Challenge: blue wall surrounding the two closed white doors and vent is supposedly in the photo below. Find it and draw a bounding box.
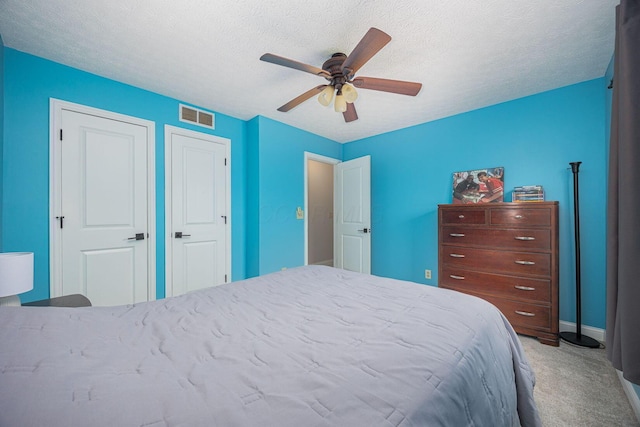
[0,48,246,301]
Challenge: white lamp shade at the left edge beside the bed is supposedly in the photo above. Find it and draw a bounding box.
[0,252,33,297]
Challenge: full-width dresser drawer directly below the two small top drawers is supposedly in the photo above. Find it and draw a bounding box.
[440,226,551,251]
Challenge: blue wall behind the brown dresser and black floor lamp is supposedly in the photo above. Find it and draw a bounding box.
[344,78,608,328]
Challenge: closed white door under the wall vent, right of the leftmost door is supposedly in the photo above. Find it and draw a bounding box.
[166,127,231,296]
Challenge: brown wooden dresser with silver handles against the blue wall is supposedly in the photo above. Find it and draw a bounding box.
[438,202,559,346]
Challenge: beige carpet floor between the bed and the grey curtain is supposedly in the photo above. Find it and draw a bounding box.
[520,335,640,427]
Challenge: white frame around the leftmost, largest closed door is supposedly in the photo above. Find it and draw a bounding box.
[49,98,156,301]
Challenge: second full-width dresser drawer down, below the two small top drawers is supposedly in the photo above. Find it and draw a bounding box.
[441,245,551,277]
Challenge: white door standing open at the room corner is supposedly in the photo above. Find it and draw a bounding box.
[333,156,371,273]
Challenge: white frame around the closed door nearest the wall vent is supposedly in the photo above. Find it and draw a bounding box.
[164,125,233,296]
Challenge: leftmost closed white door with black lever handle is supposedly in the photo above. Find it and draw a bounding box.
[52,102,155,306]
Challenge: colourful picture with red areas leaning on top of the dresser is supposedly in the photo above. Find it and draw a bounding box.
[452,167,504,204]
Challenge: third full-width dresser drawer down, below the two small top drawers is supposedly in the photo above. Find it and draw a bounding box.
[439,266,551,304]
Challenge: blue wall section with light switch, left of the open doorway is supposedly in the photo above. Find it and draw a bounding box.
[247,117,343,276]
